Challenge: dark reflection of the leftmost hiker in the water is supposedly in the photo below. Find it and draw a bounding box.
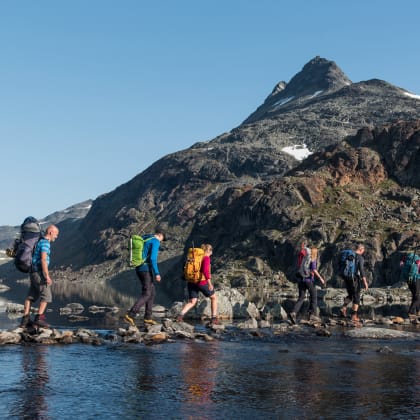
[12,346,50,420]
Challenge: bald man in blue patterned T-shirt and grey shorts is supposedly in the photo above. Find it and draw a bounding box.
[20,225,59,328]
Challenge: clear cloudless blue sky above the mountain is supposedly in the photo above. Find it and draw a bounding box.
[0,0,420,225]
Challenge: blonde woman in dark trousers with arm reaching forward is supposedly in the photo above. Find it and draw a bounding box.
[289,247,325,324]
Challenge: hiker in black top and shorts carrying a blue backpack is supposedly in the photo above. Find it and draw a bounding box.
[340,244,368,322]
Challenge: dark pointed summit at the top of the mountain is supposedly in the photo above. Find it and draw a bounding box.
[244,56,352,124]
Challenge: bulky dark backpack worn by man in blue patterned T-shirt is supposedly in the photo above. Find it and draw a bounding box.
[6,216,42,273]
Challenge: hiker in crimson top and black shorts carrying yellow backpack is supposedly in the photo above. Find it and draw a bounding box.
[176,244,218,325]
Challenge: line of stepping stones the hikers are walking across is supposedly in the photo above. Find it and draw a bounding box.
[0,316,420,346]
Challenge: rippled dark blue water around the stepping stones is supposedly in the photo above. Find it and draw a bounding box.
[0,272,420,420]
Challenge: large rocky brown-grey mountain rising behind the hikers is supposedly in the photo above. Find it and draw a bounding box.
[0,57,420,305]
